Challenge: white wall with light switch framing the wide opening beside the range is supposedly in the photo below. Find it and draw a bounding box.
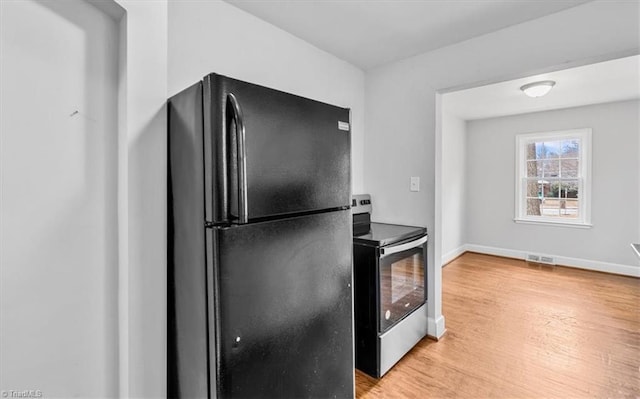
[364,1,640,335]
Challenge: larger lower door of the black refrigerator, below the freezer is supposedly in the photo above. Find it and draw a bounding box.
[207,210,354,398]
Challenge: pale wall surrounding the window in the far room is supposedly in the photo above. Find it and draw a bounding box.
[466,101,640,267]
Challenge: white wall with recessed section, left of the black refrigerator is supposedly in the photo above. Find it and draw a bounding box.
[0,0,167,397]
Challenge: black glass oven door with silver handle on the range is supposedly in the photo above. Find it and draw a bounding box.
[378,235,428,334]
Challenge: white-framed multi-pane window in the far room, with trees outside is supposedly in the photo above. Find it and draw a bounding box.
[515,129,591,227]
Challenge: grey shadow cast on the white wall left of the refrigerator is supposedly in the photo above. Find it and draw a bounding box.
[128,106,167,396]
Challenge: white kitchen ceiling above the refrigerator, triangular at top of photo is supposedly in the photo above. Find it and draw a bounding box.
[225,0,589,70]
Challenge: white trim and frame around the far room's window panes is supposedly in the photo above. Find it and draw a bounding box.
[514,128,593,228]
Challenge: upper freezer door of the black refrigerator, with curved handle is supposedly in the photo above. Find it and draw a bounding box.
[203,74,351,223]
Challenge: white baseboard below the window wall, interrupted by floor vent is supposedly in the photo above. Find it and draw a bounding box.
[464,244,640,277]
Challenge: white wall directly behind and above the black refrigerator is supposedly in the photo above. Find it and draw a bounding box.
[168,0,364,193]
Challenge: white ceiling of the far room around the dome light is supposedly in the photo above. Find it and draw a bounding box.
[443,55,640,120]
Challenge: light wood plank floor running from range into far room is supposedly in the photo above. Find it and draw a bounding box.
[356,253,640,398]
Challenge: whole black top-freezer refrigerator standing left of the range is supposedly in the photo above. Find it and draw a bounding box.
[167,74,354,398]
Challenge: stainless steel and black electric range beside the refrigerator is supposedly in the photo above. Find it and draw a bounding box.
[351,194,428,378]
